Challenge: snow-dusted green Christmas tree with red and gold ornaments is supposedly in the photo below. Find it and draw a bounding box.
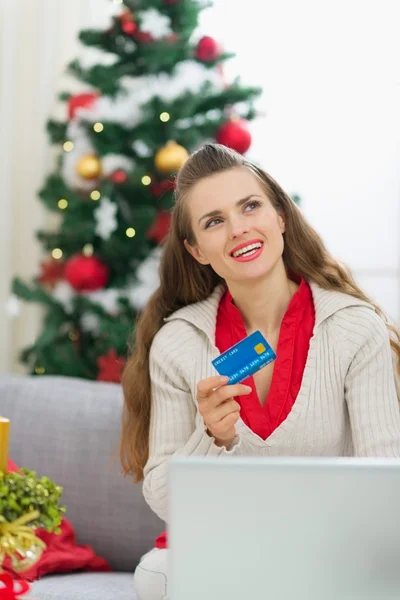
[13,0,261,381]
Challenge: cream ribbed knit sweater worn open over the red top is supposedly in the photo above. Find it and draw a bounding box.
[143,283,400,520]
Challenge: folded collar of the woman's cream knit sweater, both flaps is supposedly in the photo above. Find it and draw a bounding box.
[164,281,373,344]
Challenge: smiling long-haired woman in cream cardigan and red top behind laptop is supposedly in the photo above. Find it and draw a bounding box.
[121,144,400,600]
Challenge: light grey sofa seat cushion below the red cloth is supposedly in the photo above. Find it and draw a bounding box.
[29,573,137,600]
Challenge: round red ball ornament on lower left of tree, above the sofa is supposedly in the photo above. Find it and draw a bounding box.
[64,254,109,292]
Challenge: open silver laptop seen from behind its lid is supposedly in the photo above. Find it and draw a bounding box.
[168,457,400,600]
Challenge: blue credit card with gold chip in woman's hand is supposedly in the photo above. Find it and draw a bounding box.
[212,331,276,384]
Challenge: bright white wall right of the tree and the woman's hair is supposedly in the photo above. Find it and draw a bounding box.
[202,0,400,322]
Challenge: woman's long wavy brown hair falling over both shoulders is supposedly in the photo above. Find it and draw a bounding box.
[120,144,400,481]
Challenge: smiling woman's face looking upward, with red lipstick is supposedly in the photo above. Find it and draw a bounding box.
[185,168,285,285]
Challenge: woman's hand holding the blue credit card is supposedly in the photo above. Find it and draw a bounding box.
[197,376,251,447]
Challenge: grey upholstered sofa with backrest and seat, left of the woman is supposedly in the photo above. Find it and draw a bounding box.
[0,375,165,600]
